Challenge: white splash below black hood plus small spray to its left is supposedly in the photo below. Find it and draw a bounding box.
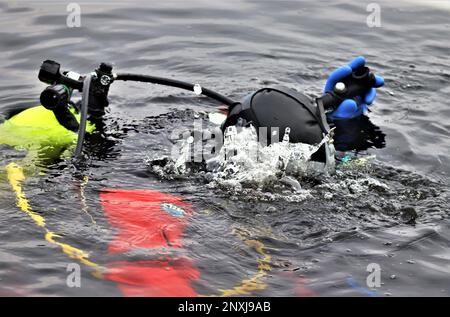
[146,126,331,193]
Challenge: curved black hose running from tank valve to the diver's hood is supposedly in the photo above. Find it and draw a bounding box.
[115,74,237,107]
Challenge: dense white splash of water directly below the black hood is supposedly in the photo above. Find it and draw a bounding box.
[209,126,328,189]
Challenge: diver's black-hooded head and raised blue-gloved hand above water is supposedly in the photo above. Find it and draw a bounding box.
[222,56,384,166]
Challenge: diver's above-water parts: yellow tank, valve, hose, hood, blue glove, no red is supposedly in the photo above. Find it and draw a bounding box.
[0,56,384,165]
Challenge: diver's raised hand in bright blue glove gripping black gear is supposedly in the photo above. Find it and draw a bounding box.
[324,56,384,121]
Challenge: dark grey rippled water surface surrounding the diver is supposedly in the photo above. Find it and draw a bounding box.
[0,0,450,296]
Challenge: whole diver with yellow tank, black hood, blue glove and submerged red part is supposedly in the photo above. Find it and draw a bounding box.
[0,57,384,296]
